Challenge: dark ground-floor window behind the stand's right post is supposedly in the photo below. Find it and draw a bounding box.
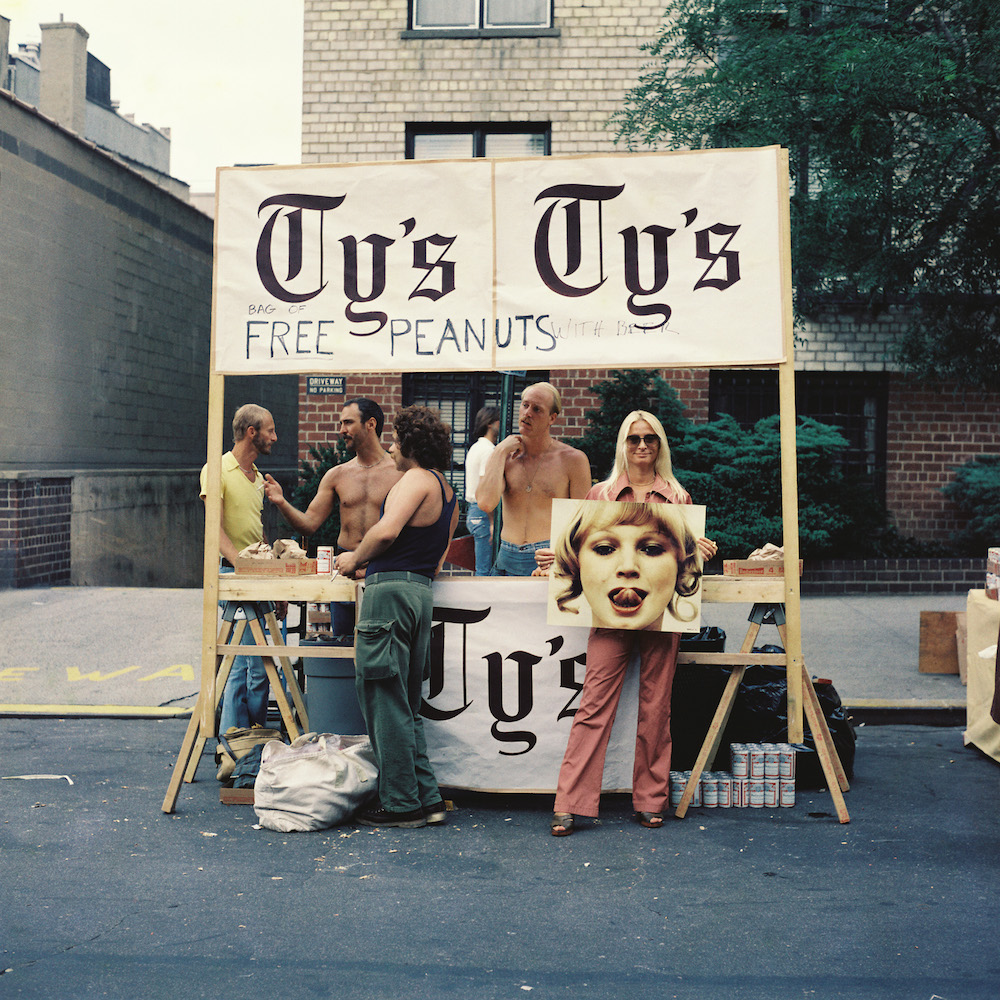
[709,369,888,502]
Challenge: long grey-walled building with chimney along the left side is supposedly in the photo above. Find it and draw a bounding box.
[0,17,297,587]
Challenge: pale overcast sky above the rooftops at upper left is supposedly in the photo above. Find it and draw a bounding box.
[0,0,303,191]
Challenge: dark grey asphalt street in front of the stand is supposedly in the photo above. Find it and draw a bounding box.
[0,716,1000,1000]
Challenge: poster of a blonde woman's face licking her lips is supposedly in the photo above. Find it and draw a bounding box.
[546,500,705,632]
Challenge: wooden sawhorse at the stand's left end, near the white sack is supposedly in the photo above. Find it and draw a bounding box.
[163,601,309,812]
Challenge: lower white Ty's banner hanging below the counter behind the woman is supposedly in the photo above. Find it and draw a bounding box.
[422,577,638,792]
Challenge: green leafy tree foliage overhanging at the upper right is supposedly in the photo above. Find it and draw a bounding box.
[614,0,1000,388]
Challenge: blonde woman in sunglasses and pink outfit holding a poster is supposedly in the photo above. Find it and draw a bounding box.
[551,410,717,837]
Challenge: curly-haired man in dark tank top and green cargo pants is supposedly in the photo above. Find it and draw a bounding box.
[336,406,458,827]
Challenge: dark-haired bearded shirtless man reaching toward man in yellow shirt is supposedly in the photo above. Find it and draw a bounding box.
[264,397,403,572]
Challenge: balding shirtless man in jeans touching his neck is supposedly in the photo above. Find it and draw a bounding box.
[476,382,591,576]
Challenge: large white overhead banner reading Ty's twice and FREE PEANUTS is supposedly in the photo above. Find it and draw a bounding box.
[213,147,787,374]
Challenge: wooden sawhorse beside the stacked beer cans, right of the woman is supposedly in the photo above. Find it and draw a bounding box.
[674,604,851,823]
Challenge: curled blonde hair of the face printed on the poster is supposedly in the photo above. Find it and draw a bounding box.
[553,500,702,621]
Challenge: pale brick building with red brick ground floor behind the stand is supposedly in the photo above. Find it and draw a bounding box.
[299,0,1000,556]
